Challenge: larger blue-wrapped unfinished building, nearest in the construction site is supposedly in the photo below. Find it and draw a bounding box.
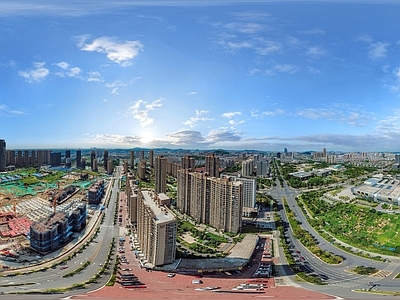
[30,201,87,254]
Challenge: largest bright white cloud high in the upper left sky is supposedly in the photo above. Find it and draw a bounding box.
[77,35,143,67]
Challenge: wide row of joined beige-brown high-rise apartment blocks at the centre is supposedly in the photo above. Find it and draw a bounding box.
[177,169,243,233]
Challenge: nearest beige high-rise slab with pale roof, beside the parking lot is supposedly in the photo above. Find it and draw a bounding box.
[137,190,177,266]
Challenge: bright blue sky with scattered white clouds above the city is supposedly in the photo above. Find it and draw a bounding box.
[0,0,400,152]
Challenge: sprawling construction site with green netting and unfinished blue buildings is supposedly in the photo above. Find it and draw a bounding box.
[0,170,104,270]
